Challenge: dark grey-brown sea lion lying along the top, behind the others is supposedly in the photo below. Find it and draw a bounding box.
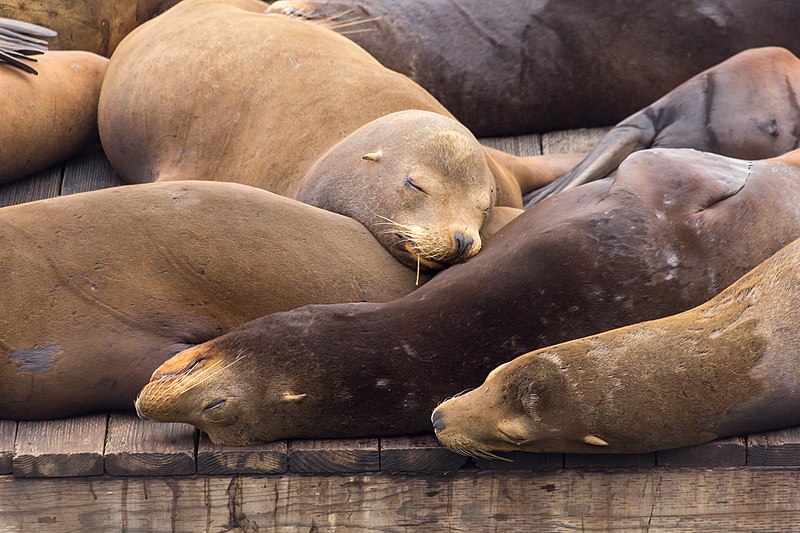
[270,0,800,137]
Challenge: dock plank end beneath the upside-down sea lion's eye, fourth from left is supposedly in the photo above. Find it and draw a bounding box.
[197,433,289,475]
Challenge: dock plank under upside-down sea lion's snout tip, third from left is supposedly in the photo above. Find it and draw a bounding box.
[105,414,195,476]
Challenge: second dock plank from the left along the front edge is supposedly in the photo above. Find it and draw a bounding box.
[13,415,107,477]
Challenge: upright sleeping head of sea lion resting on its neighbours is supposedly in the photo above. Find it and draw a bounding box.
[297,111,495,270]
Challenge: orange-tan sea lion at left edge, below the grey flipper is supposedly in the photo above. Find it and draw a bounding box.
[0,51,108,183]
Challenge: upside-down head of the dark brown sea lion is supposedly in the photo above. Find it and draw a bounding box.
[136,328,326,446]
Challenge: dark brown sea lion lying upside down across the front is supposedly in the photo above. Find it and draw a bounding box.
[137,149,800,444]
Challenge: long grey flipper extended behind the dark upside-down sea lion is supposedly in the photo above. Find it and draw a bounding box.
[523,111,656,209]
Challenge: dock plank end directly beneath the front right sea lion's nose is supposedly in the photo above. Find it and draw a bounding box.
[380,435,467,472]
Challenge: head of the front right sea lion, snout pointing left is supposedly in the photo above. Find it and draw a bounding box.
[431,349,608,458]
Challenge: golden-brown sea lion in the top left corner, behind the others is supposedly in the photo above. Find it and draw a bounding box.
[2,0,180,57]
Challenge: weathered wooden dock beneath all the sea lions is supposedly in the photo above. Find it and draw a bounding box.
[0,130,800,533]
